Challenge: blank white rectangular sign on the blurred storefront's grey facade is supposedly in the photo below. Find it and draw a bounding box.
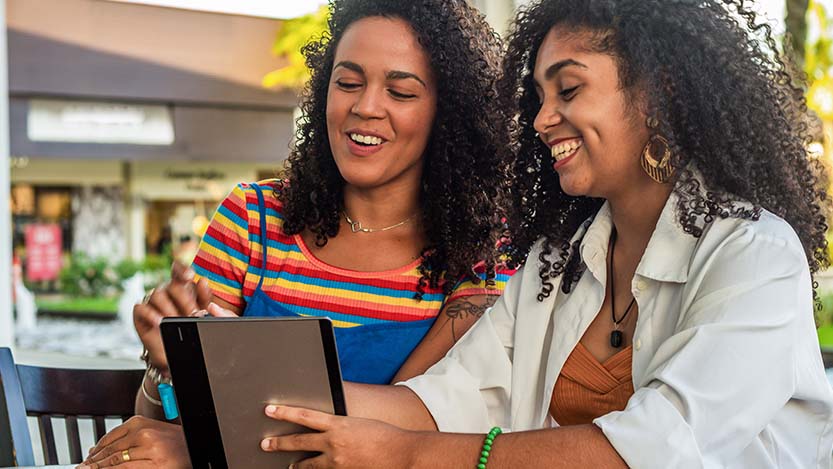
[27,99,174,145]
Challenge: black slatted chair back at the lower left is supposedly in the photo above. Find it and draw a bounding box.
[0,347,144,466]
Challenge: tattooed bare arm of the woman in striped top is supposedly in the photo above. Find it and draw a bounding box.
[392,295,498,383]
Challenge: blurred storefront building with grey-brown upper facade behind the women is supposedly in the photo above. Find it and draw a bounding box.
[7,0,297,286]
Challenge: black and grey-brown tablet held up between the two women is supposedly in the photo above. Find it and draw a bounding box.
[161,318,347,469]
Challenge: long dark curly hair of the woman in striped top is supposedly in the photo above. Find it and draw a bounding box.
[276,0,511,298]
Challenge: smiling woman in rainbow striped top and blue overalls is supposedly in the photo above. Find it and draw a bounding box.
[81,0,512,467]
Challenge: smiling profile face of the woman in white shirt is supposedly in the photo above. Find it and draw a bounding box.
[533,26,650,199]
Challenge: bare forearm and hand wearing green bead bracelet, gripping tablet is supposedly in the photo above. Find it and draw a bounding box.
[261,402,627,469]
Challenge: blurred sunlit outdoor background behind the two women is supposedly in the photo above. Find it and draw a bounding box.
[0,0,833,370]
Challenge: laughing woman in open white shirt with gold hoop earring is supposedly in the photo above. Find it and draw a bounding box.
[133,0,833,469]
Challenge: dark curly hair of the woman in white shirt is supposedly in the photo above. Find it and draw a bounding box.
[499,0,829,301]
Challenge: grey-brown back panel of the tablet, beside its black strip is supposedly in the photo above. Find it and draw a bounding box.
[166,319,340,469]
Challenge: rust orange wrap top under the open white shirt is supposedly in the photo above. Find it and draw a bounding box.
[550,342,633,425]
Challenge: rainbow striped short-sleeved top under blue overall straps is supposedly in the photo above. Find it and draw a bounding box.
[193,179,514,329]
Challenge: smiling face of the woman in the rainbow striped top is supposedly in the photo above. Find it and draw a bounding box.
[327,17,437,189]
